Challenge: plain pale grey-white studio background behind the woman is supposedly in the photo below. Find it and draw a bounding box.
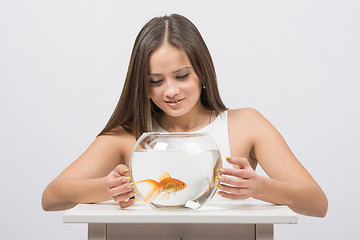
[0,0,360,240]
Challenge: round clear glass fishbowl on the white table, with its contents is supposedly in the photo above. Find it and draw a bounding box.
[130,132,222,209]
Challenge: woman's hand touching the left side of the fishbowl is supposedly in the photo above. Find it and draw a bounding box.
[105,164,136,208]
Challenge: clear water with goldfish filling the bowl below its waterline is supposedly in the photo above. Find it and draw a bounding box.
[131,150,221,209]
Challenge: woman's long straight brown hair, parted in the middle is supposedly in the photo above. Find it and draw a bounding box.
[98,14,227,138]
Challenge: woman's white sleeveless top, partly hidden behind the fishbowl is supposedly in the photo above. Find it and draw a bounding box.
[153,110,233,168]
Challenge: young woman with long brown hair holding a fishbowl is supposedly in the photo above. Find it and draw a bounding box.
[42,14,328,217]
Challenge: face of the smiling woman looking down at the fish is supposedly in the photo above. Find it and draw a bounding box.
[148,44,202,117]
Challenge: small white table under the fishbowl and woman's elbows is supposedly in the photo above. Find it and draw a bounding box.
[64,200,298,240]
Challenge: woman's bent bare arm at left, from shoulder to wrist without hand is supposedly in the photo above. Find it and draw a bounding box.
[42,129,134,211]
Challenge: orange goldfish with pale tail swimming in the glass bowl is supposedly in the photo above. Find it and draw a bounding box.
[135,172,186,202]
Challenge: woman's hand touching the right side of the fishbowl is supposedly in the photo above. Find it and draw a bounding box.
[218,157,258,199]
